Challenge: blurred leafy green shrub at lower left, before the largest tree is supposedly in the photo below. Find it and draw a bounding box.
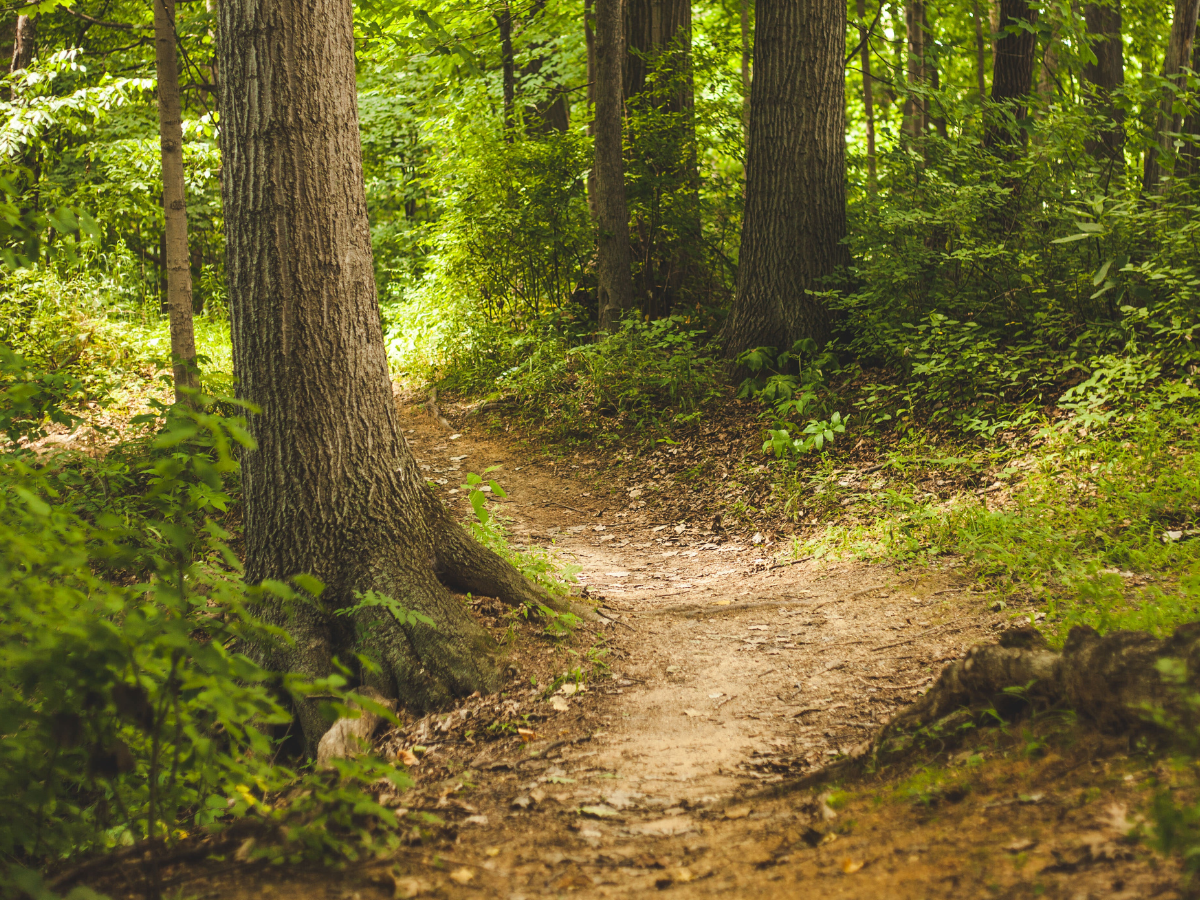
[0,382,406,883]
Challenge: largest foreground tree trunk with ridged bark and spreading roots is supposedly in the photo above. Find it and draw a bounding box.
[220,0,571,752]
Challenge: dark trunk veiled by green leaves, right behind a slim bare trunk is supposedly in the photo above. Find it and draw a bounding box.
[623,0,700,318]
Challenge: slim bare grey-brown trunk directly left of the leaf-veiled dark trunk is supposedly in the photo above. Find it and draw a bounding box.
[593,0,634,331]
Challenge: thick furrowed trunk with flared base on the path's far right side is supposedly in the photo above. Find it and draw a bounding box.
[724,0,846,358]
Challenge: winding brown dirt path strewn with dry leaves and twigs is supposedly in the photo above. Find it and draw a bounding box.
[117,403,1186,900]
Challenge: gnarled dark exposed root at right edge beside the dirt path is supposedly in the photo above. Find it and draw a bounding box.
[875,623,1200,751]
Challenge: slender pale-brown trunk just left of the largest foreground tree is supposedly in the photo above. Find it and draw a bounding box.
[154,0,199,402]
